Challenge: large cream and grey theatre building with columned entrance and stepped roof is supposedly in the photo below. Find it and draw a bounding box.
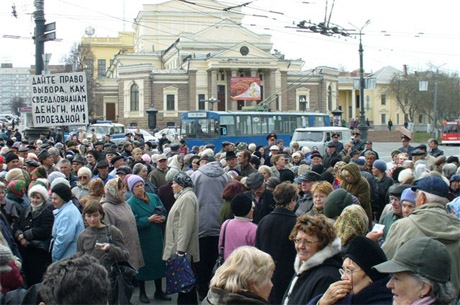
[92,0,339,128]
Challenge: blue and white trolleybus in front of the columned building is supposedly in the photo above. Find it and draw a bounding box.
[180,111,330,149]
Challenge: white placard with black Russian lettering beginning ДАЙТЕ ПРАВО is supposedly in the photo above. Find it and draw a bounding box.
[31,72,88,127]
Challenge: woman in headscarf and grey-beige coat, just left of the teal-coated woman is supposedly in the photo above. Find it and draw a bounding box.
[101,178,144,269]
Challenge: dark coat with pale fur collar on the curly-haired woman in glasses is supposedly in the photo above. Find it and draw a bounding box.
[282,238,342,305]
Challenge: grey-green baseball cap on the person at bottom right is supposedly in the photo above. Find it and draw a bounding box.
[373,236,451,283]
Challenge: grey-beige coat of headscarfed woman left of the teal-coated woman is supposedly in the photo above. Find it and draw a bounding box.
[102,200,144,269]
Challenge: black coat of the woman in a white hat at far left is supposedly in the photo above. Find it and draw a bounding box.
[13,203,54,286]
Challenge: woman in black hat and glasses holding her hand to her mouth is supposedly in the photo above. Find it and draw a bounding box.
[308,236,393,305]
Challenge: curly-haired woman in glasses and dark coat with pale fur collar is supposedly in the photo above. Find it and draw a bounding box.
[282,215,342,305]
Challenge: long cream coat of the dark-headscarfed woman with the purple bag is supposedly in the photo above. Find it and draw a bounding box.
[163,187,200,263]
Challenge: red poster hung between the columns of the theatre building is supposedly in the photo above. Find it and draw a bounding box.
[230,77,261,101]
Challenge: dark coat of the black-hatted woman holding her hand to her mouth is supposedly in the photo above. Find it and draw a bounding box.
[307,276,393,305]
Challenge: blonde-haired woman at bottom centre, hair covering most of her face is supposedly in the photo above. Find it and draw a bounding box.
[202,246,275,305]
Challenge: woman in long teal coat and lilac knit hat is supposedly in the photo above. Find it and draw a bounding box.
[128,175,171,303]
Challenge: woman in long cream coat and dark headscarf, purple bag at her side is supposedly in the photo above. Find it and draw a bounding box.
[163,172,200,304]
